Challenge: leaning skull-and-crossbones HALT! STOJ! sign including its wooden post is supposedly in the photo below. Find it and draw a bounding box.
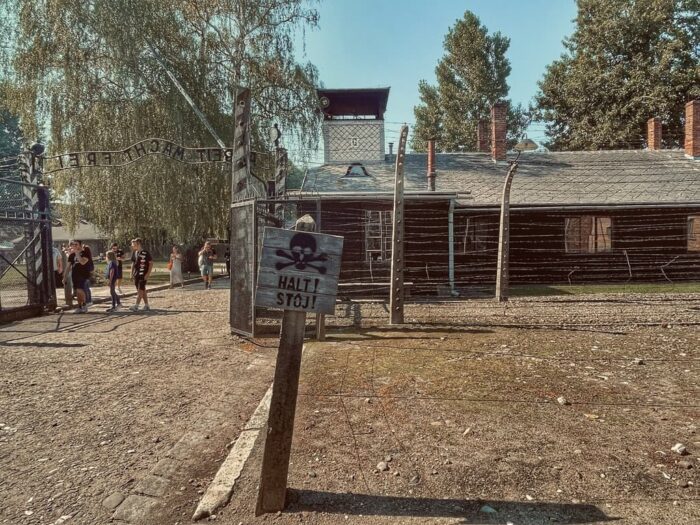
[255,215,343,516]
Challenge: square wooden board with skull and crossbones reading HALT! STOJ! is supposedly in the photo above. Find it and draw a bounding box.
[255,228,343,314]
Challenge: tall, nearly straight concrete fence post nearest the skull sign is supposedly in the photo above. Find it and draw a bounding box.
[389,124,408,324]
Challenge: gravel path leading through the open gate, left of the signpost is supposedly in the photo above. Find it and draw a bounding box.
[0,281,276,525]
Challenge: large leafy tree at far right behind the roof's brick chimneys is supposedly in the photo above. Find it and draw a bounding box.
[535,0,700,150]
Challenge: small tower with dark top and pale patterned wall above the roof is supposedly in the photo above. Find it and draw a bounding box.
[318,88,389,163]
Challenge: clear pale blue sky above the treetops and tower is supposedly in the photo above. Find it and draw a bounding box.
[298,0,576,151]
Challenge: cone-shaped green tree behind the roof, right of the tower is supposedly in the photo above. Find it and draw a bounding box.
[411,11,527,152]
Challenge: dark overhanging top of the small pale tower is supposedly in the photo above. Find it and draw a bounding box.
[317,87,389,120]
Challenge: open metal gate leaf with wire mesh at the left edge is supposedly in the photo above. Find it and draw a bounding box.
[0,152,56,322]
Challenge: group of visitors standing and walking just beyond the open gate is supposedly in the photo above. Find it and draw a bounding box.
[58,238,224,313]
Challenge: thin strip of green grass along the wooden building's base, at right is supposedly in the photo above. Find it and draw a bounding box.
[509,282,700,297]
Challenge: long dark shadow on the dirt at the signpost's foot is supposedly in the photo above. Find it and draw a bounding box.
[287,489,620,525]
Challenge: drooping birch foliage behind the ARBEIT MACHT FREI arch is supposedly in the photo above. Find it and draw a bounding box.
[0,0,319,243]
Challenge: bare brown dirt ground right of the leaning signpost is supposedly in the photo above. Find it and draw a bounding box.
[217,296,700,525]
